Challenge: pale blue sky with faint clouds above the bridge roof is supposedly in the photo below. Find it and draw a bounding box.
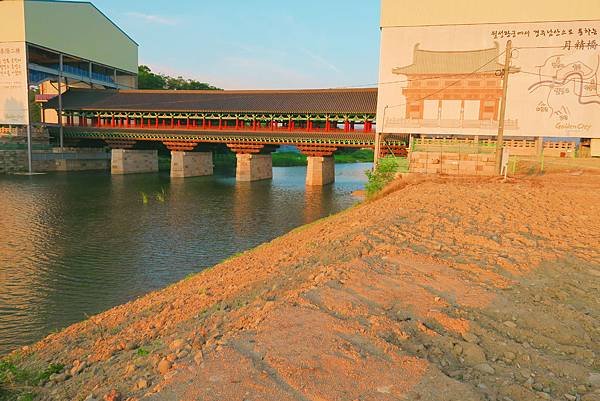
[92,0,380,89]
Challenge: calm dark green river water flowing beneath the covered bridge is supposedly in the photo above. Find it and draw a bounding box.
[0,164,369,355]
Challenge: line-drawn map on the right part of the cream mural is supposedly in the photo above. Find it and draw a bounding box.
[529,54,600,125]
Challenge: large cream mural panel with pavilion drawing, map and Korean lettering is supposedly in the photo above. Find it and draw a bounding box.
[378,21,600,138]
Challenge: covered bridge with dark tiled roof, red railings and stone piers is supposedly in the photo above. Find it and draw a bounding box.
[48,88,404,186]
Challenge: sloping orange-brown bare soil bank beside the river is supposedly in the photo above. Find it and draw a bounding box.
[5,172,600,401]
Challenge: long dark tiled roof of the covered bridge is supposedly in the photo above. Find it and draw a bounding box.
[52,88,377,114]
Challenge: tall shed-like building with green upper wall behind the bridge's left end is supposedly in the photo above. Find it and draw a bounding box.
[0,0,138,125]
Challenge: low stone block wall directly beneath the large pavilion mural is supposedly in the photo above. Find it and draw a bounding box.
[409,152,496,176]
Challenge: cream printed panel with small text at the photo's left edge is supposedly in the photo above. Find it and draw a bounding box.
[0,42,29,125]
